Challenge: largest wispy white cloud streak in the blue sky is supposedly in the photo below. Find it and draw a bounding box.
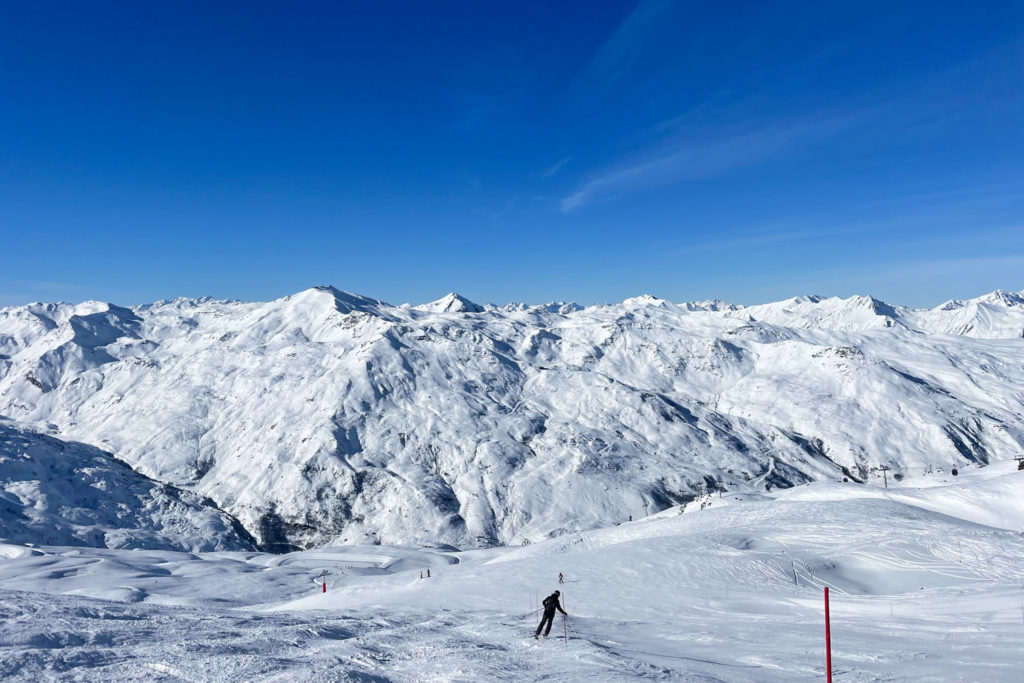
[560,111,870,212]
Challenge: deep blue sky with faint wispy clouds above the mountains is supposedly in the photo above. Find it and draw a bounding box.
[0,0,1024,306]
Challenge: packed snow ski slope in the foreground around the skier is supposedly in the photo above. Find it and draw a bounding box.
[0,461,1024,682]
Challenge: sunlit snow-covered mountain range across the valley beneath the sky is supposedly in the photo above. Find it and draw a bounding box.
[0,287,1024,548]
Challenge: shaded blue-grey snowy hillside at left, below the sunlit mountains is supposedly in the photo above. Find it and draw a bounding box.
[0,419,255,552]
